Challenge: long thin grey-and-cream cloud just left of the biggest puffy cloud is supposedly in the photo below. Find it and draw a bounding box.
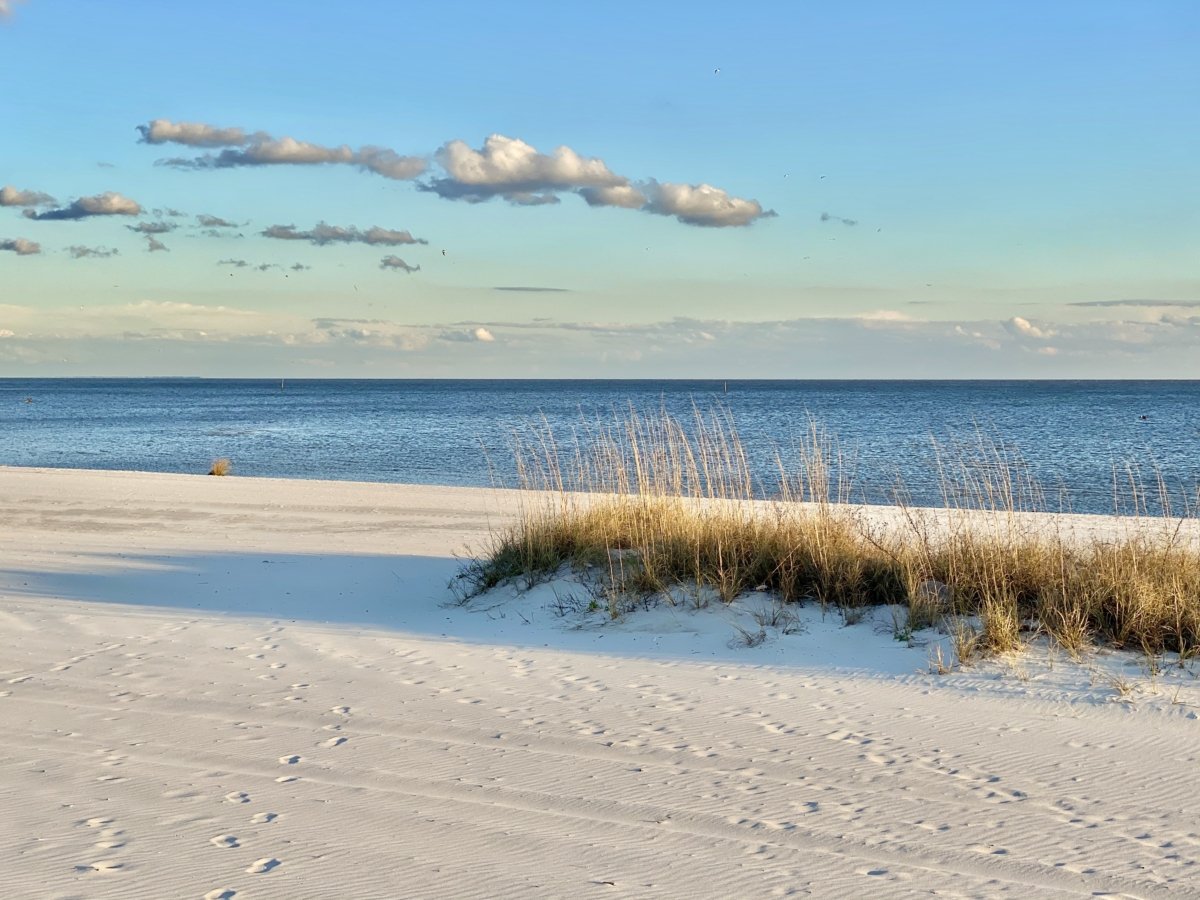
[138,119,426,180]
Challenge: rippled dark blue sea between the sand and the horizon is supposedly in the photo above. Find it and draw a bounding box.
[0,379,1200,512]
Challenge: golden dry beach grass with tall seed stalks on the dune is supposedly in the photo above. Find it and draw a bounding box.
[458,410,1200,661]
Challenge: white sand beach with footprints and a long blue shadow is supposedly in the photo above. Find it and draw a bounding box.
[0,468,1200,900]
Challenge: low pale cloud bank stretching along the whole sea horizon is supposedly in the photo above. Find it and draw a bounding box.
[7,301,1200,378]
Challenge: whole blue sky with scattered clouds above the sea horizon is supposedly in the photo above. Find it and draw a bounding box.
[0,0,1200,379]
